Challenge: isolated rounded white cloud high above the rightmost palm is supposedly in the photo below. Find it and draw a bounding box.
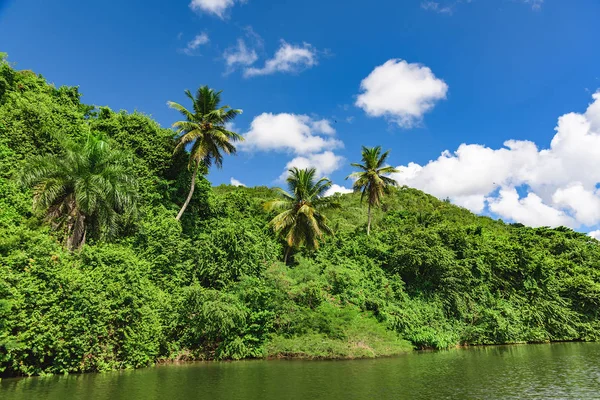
[356,59,448,128]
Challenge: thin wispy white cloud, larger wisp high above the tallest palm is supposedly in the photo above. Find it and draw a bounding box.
[244,40,318,77]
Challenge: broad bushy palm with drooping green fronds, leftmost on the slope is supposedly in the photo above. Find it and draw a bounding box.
[19,135,137,250]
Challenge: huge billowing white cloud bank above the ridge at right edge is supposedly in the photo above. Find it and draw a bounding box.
[394,92,600,228]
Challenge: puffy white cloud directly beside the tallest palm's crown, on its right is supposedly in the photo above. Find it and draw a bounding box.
[239,113,343,154]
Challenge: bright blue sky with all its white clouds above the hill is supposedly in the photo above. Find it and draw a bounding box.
[0,0,600,232]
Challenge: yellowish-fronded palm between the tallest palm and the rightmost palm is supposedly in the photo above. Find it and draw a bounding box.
[265,168,339,264]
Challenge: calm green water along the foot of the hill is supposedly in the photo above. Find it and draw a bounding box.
[0,343,600,400]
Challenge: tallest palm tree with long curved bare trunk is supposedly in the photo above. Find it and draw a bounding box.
[167,86,244,220]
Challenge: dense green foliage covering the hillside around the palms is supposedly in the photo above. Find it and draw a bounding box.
[0,54,600,376]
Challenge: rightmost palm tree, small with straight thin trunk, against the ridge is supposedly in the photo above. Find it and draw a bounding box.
[346,146,399,235]
